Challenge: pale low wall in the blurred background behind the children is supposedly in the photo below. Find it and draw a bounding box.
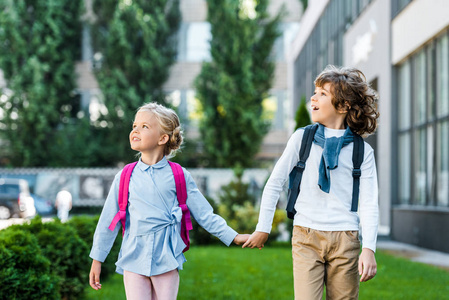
[0,168,270,206]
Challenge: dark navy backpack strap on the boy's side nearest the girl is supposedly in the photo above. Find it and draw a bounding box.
[287,124,318,219]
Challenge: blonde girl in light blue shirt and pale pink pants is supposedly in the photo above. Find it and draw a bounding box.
[89,103,249,299]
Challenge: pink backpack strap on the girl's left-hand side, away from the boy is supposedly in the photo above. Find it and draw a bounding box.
[108,162,137,236]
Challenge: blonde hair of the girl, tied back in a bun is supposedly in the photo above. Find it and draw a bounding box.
[137,102,183,158]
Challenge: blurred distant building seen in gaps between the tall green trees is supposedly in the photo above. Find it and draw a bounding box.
[75,0,303,161]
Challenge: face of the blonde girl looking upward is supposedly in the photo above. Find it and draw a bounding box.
[129,111,168,155]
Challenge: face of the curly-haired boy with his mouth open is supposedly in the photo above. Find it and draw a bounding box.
[310,83,346,129]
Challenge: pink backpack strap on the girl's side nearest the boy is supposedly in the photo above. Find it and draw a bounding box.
[168,161,193,252]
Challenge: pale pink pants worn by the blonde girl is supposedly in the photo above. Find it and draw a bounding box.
[123,269,179,300]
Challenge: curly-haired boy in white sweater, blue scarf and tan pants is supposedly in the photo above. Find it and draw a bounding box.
[243,66,379,300]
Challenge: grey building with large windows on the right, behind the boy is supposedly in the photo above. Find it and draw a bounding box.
[289,0,449,252]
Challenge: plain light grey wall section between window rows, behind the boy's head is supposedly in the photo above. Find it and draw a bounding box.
[343,0,393,235]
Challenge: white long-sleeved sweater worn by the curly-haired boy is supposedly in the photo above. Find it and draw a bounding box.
[256,128,379,251]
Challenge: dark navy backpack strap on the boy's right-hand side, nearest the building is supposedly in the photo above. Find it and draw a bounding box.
[351,133,365,211]
